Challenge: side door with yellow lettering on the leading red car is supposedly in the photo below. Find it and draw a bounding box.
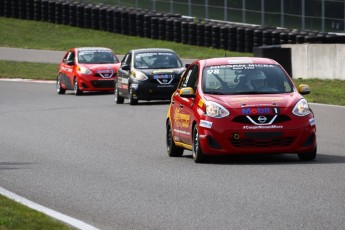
[170,64,199,145]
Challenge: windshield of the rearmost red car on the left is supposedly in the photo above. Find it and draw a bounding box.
[78,49,119,64]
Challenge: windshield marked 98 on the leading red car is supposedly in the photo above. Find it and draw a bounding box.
[202,64,293,95]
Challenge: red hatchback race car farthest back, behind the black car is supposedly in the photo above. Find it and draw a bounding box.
[56,47,120,95]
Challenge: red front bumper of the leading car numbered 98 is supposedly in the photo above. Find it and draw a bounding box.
[195,117,316,155]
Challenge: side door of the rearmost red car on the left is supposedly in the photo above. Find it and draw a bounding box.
[59,50,75,89]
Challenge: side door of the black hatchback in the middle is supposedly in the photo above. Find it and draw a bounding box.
[117,52,132,97]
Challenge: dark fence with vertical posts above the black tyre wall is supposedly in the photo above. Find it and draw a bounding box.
[89,0,345,32]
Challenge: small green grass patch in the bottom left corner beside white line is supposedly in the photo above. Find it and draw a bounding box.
[0,195,74,230]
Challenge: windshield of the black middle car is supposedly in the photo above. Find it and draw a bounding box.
[134,52,182,69]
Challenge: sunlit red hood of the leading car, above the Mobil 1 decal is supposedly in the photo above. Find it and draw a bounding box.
[205,92,303,109]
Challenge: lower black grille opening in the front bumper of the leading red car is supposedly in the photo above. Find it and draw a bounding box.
[229,137,295,148]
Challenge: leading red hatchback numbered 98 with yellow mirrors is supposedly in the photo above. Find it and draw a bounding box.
[166,57,317,163]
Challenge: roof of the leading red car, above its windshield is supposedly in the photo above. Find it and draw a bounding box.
[199,57,278,66]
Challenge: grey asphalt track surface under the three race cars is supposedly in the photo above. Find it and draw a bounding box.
[0,47,345,229]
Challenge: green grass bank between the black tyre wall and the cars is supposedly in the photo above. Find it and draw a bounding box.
[0,17,247,58]
